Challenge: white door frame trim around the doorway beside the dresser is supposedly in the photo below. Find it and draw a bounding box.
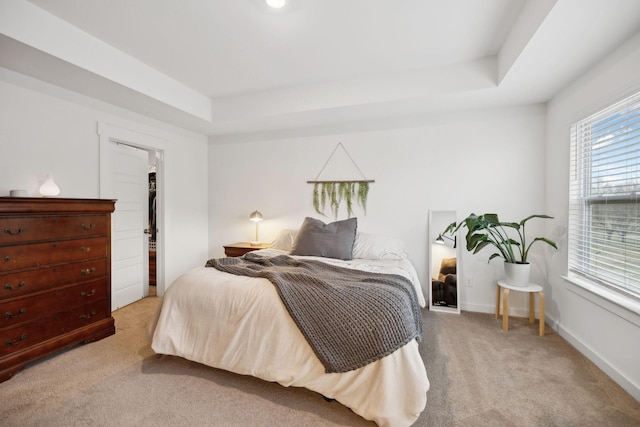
[97,122,166,296]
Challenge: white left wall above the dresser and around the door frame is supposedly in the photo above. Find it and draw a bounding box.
[0,70,208,294]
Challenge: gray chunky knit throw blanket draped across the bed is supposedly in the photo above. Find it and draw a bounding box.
[206,253,422,373]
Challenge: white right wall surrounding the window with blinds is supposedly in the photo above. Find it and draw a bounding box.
[545,30,640,399]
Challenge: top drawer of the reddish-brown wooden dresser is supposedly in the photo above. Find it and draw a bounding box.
[0,215,110,245]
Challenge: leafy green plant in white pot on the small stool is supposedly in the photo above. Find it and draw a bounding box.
[446,213,558,286]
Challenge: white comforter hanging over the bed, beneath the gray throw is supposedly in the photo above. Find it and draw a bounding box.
[151,250,429,426]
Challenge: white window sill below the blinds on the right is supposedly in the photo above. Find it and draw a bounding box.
[562,274,640,326]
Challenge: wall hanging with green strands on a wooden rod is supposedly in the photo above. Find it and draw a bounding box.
[307,142,375,219]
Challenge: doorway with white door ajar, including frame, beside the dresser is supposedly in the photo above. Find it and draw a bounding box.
[98,123,164,310]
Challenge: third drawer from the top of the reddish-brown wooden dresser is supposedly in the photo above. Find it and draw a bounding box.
[0,258,109,301]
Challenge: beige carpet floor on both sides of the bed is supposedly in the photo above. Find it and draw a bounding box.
[0,297,640,427]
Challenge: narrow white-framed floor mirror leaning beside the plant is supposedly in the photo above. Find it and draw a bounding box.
[427,210,462,313]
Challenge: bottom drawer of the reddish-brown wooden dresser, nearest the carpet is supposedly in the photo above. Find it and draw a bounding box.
[0,300,111,357]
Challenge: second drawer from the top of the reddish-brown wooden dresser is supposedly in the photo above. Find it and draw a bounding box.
[0,237,108,273]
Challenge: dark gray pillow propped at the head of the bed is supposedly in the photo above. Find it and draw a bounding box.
[291,217,358,260]
